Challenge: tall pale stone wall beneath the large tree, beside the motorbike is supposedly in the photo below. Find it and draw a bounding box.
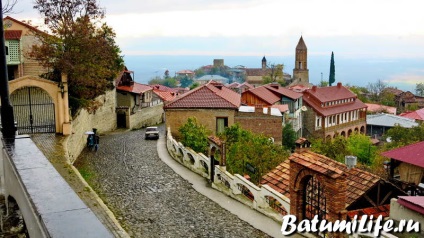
[66,89,116,163]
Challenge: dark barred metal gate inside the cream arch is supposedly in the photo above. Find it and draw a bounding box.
[10,87,56,134]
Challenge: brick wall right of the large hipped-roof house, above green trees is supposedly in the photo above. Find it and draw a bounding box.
[234,108,283,144]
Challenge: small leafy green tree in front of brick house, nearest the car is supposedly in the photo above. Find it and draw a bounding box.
[178,117,211,154]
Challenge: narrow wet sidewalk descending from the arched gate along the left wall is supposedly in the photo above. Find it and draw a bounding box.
[31,134,129,237]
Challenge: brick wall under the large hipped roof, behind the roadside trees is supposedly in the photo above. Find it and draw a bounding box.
[165,109,236,138]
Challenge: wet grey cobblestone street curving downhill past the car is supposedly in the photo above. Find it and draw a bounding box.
[75,126,268,237]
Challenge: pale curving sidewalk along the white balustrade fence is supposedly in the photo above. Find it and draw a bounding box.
[157,136,290,237]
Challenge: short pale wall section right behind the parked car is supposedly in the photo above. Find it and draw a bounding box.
[129,103,164,129]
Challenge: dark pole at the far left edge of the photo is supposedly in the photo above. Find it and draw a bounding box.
[0,0,16,139]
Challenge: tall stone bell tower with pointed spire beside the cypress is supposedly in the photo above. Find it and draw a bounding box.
[293,36,309,85]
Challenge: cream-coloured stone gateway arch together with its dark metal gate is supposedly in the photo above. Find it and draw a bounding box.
[9,76,71,135]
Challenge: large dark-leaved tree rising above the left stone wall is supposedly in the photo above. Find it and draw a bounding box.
[29,0,123,99]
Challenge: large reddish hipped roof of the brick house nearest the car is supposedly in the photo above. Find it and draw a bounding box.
[164,81,240,109]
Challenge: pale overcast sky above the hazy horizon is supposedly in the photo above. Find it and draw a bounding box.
[8,0,424,58]
